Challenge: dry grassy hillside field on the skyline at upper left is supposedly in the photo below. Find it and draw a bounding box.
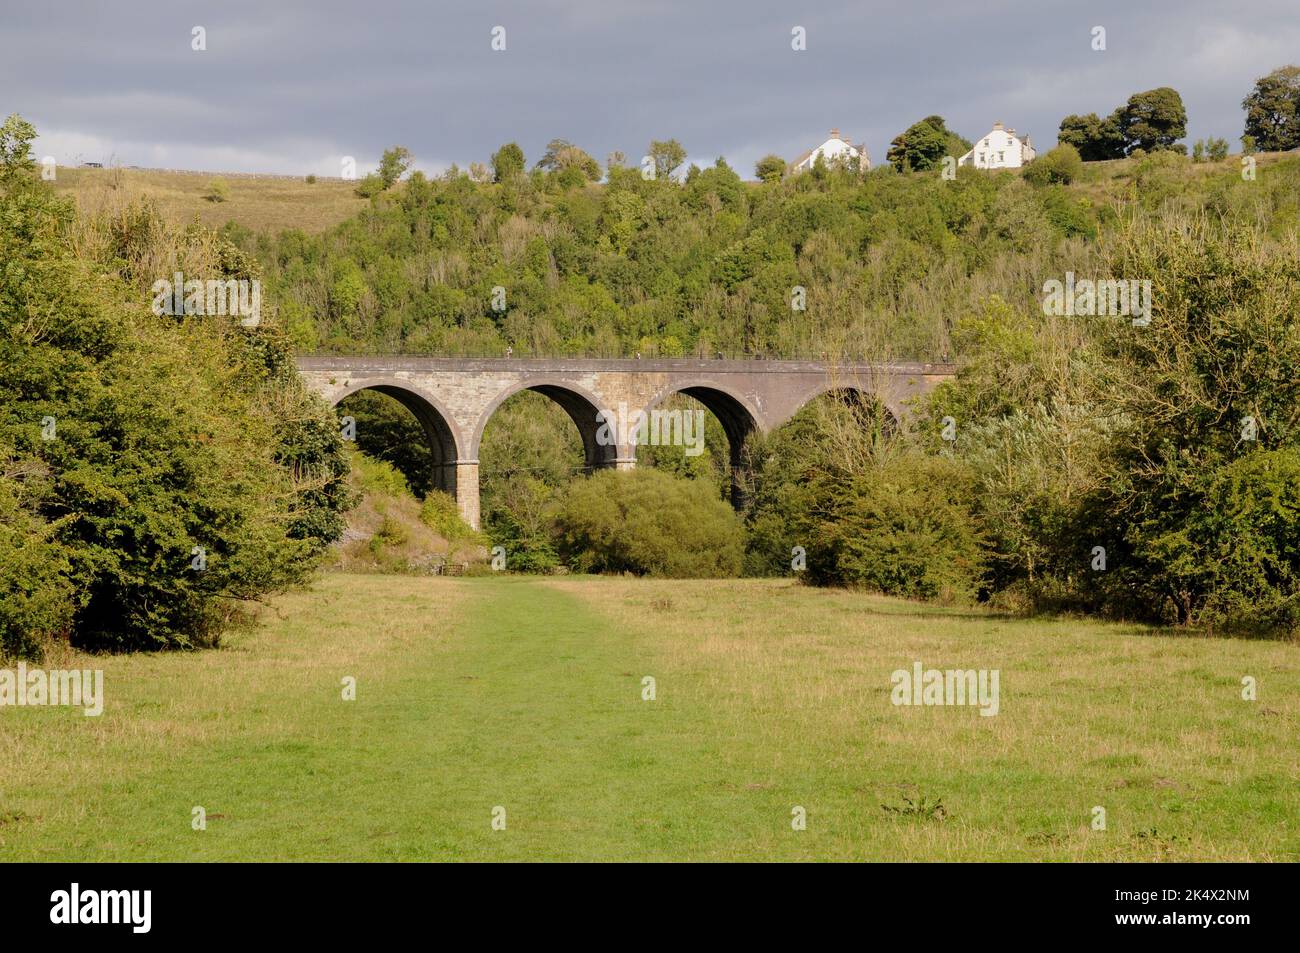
[53,169,368,234]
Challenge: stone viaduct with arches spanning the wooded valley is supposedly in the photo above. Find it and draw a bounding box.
[298,356,953,528]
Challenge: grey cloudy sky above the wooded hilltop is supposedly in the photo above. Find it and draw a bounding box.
[0,0,1300,176]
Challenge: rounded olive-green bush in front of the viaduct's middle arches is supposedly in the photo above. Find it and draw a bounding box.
[555,468,744,577]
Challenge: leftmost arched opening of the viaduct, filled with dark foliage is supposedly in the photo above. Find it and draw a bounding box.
[334,384,459,498]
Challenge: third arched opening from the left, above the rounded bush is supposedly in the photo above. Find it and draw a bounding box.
[637,384,758,510]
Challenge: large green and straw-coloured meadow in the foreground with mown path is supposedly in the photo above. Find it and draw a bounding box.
[0,575,1300,861]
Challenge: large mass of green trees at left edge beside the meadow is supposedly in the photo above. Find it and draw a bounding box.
[0,115,348,651]
